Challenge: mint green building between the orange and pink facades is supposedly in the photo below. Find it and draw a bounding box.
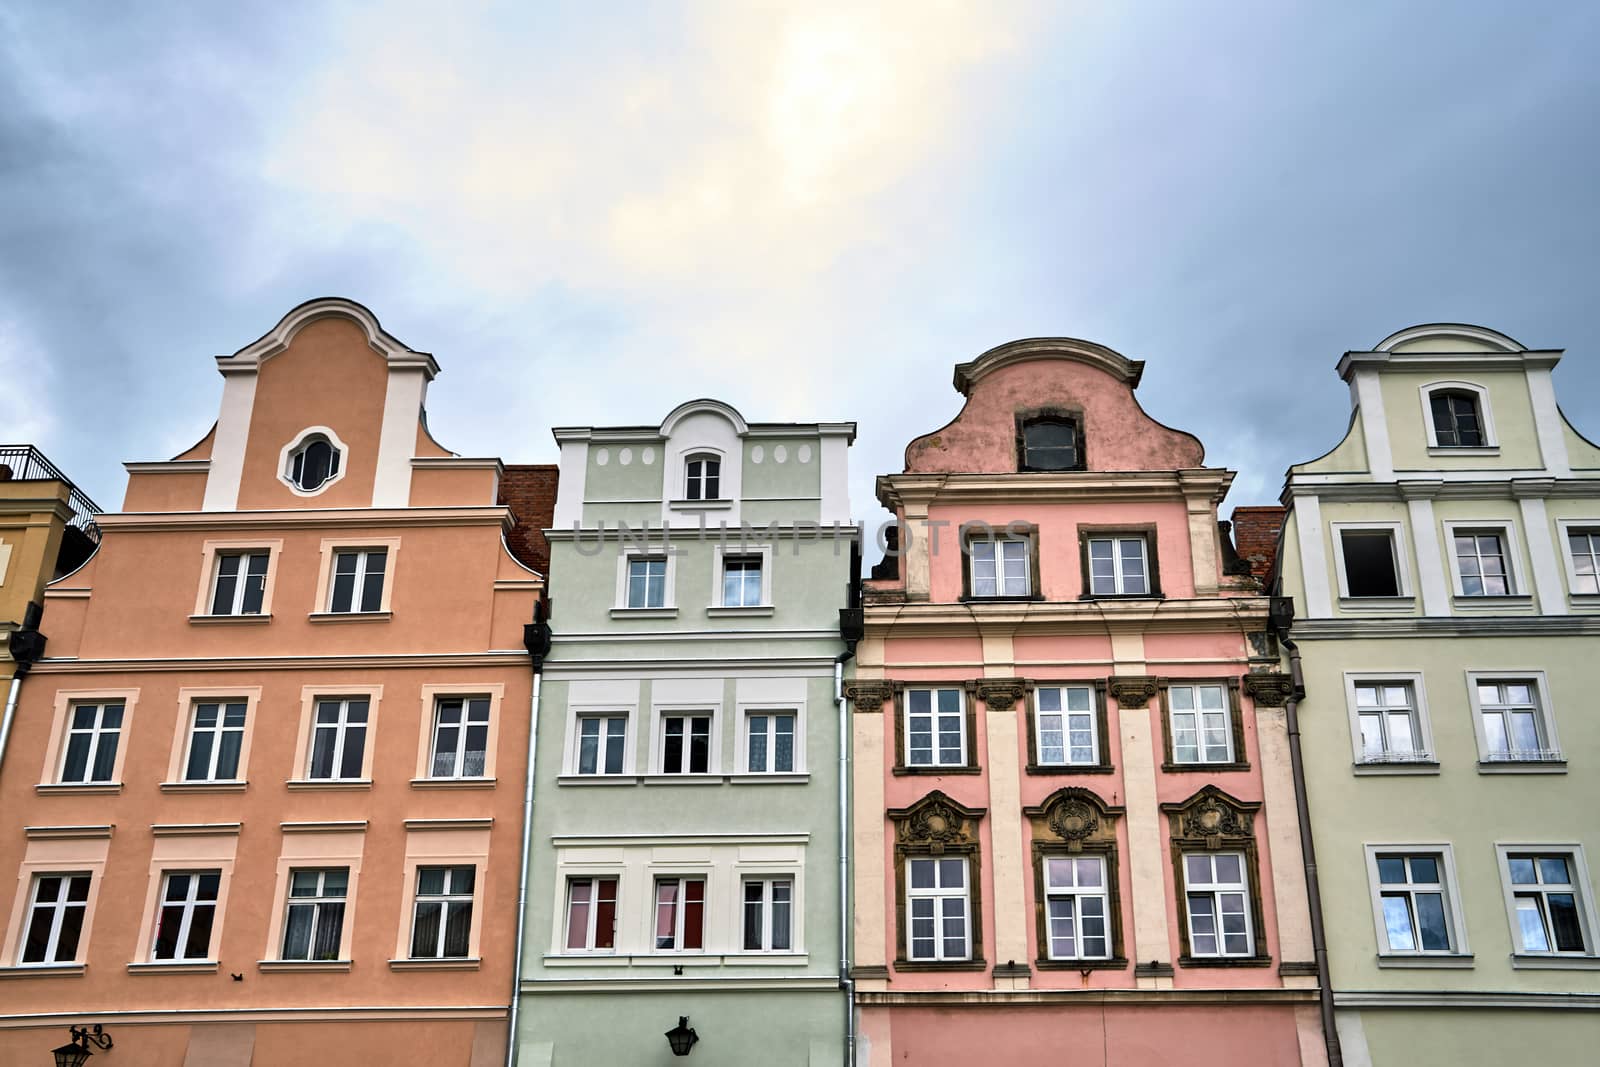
[517,400,859,1067]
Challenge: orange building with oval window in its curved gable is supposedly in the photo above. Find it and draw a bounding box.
[0,299,554,1067]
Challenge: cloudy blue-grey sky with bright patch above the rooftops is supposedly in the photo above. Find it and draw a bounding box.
[0,0,1600,550]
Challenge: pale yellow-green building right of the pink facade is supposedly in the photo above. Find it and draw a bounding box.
[1278,325,1600,1067]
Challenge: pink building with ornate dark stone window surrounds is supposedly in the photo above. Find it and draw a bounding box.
[846,339,1326,1067]
